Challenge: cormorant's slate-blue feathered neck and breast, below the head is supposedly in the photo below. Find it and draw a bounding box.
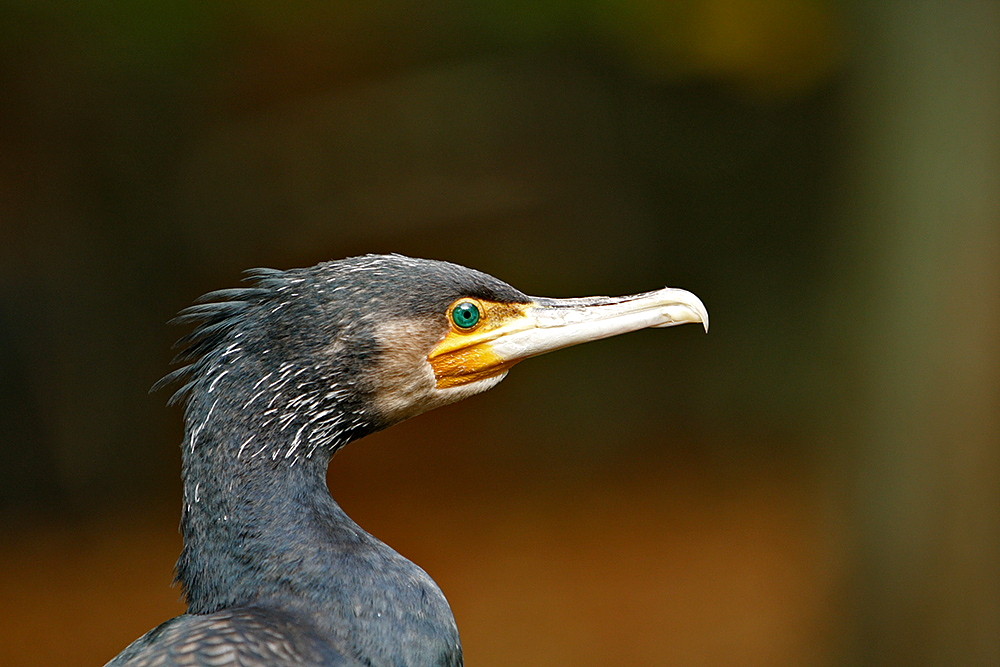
[177,388,462,665]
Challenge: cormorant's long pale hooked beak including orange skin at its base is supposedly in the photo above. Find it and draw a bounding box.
[428,287,708,388]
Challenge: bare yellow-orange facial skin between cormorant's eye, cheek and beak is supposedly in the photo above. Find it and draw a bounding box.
[427,299,529,389]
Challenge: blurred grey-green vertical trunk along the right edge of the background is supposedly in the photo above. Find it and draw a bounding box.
[839,0,1000,665]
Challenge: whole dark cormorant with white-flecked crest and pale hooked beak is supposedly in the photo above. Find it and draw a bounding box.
[107,254,708,667]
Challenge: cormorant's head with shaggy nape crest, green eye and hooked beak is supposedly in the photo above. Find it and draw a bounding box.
[161,255,708,460]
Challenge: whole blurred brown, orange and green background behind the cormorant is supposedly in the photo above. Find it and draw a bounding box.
[0,0,1000,667]
